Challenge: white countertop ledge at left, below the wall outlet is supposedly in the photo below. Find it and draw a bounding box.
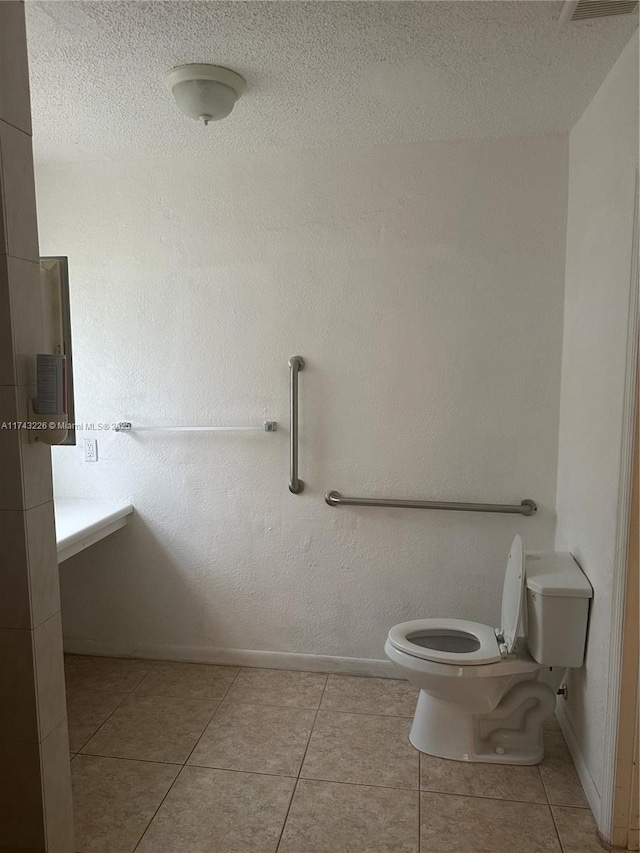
[54,498,133,563]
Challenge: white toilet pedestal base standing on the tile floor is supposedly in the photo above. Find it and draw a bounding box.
[409,690,551,764]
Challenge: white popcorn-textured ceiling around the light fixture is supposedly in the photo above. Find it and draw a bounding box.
[27,0,637,161]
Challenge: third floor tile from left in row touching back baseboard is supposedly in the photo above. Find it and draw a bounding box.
[226,669,327,709]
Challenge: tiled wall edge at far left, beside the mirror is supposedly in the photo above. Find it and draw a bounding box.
[0,0,74,853]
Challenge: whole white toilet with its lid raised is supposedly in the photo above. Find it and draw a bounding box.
[385,536,593,764]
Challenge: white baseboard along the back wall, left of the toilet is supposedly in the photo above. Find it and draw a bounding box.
[64,637,398,678]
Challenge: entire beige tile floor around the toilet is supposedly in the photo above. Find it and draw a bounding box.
[66,656,603,853]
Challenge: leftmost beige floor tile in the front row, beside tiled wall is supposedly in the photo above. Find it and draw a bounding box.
[71,755,180,853]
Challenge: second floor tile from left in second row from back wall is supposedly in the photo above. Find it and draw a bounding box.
[81,694,218,764]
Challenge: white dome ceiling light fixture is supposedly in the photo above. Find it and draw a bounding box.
[164,64,247,125]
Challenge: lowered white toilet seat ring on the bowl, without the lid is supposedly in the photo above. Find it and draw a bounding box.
[389,619,502,666]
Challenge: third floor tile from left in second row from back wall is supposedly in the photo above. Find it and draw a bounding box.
[189,702,316,776]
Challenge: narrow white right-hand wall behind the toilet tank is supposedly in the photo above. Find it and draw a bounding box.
[556,35,638,815]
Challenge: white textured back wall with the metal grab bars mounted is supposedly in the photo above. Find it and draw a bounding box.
[37,133,567,659]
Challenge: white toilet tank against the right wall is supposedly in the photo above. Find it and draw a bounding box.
[525,551,593,668]
